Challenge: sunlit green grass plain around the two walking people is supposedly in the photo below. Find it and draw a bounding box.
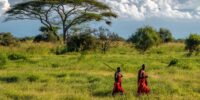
[0,42,200,100]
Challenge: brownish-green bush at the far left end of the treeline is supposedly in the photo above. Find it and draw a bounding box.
[0,33,16,46]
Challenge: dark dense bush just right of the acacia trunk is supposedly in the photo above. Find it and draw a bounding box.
[67,32,96,51]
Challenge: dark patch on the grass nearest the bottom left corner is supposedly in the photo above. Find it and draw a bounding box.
[0,76,19,83]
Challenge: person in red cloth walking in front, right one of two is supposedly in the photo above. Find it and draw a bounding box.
[137,64,150,96]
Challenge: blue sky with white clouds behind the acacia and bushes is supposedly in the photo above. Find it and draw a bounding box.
[0,0,200,38]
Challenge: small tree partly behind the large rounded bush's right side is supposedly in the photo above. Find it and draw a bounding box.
[158,28,173,43]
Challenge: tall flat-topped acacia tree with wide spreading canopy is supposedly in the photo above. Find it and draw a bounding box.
[6,0,117,43]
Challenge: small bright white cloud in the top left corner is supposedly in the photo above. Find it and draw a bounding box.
[0,0,10,16]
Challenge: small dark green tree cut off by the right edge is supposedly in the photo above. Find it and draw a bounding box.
[185,34,200,55]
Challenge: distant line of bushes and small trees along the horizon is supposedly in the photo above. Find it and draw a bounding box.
[0,26,200,55]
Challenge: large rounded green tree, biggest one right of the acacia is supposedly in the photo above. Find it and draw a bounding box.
[129,26,160,52]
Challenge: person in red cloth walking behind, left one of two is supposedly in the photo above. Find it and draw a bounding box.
[112,67,124,96]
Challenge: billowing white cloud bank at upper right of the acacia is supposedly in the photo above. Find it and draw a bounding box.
[99,0,200,20]
